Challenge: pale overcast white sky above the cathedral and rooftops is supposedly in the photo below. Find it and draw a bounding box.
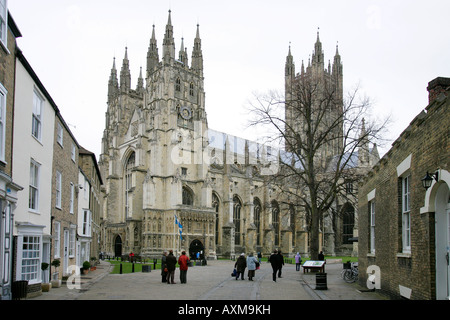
[8,0,450,160]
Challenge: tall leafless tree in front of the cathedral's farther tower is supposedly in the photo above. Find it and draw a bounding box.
[249,77,387,259]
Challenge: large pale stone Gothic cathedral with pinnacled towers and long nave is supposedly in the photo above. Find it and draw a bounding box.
[99,11,377,259]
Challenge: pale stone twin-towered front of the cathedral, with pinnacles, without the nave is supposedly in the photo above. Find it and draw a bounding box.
[100,11,215,255]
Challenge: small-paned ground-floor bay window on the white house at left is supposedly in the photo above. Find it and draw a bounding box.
[21,236,41,281]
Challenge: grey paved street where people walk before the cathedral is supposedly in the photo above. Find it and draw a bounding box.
[28,260,384,301]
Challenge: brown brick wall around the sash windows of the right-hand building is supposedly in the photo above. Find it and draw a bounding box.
[359,83,450,299]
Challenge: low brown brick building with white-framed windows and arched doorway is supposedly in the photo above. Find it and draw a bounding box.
[359,78,450,300]
